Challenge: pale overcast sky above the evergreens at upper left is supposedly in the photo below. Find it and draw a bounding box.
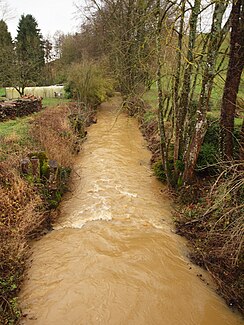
[6,0,85,37]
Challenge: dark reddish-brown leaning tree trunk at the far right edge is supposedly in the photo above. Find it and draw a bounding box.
[220,0,244,160]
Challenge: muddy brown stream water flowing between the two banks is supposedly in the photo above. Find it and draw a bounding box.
[20,97,243,325]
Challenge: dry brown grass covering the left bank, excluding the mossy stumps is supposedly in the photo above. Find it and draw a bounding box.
[0,100,84,324]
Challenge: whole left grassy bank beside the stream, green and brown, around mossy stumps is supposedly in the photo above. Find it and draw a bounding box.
[0,100,92,324]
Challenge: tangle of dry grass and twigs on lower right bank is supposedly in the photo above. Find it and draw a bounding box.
[177,161,244,313]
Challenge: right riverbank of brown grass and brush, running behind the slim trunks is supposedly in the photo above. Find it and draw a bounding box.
[134,98,244,315]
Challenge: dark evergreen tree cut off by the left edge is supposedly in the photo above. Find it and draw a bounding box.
[0,20,14,87]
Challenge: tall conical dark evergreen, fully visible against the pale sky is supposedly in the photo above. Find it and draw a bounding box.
[15,15,45,95]
